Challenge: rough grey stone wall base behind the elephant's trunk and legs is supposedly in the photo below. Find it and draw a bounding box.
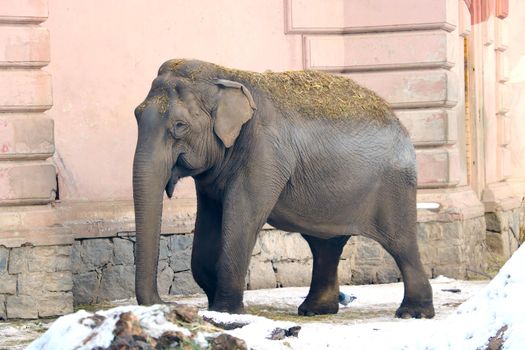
[68,217,492,305]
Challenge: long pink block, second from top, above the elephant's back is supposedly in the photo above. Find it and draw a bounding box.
[303,30,457,72]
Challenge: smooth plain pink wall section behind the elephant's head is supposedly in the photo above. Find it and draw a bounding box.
[45,0,302,200]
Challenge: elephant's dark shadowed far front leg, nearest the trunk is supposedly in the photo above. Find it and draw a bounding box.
[191,189,222,308]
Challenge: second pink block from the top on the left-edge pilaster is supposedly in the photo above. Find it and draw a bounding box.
[0,26,50,67]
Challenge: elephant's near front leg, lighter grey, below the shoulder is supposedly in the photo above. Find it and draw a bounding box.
[210,175,284,313]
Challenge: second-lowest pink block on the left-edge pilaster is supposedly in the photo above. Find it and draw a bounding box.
[0,113,55,160]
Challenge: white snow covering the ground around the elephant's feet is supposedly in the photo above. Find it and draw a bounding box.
[6,247,525,350]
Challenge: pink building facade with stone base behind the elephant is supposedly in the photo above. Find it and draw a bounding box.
[0,0,525,319]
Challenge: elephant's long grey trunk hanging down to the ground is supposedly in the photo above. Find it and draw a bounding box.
[133,148,168,305]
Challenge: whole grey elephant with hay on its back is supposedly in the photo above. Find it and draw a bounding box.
[133,59,434,318]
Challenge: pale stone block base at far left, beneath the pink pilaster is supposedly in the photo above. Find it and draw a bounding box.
[0,245,73,320]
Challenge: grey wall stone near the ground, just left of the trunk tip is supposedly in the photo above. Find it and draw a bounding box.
[98,265,135,301]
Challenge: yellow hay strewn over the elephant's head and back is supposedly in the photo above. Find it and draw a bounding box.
[159,60,396,123]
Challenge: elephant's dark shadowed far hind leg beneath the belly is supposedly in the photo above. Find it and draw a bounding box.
[298,235,350,316]
